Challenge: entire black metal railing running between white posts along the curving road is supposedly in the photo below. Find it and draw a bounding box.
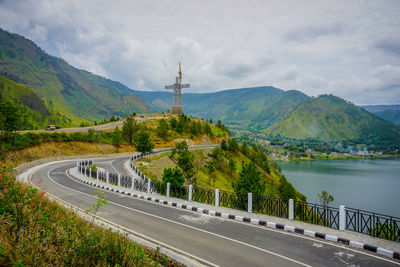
[78,149,400,245]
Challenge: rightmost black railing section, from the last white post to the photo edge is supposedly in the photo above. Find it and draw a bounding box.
[346,207,400,242]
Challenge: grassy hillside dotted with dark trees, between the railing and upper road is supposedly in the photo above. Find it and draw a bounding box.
[135,139,306,201]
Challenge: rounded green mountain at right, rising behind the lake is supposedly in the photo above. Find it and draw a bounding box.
[265,95,400,142]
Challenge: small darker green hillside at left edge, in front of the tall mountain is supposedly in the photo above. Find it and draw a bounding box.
[0,76,71,129]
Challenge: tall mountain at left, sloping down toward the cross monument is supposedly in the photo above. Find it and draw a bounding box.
[0,29,150,124]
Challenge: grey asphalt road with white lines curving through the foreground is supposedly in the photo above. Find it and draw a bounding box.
[28,157,400,267]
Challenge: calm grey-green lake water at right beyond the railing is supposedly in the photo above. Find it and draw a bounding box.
[279,159,400,217]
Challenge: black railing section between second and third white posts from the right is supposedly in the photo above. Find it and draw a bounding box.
[253,194,289,218]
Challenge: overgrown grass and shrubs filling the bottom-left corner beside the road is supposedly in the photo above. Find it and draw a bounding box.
[0,167,182,266]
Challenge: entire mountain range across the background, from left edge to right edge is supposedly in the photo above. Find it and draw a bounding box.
[0,29,400,147]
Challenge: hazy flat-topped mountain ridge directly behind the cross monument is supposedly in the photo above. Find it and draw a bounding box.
[132,86,309,132]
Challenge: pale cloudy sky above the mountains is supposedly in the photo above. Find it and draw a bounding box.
[0,0,400,105]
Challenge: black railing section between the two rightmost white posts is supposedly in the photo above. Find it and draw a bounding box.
[294,201,339,229]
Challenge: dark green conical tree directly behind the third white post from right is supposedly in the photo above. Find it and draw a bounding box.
[232,161,265,195]
